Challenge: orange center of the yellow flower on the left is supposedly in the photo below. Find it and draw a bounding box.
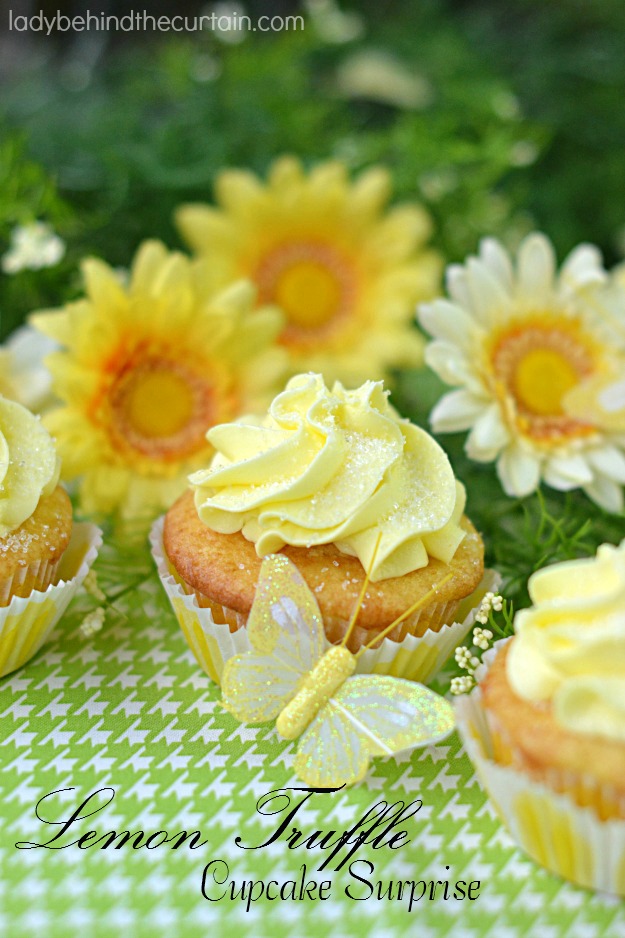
[101,348,221,462]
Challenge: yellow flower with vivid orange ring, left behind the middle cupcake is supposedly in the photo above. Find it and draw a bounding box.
[31,241,284,519]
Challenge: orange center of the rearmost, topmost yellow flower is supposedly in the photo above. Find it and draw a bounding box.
[256,242,355,345]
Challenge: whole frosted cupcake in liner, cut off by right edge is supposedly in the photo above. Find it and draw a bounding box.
[458,541,625,895]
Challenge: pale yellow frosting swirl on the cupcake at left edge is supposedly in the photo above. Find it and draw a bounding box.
[0,397,60,537]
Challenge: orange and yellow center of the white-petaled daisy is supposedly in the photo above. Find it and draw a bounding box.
[491,316,595,441]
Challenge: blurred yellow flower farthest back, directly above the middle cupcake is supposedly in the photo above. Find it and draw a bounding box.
[176,157,440,384]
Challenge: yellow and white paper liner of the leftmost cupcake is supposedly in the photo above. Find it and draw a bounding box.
[0,523,102,677]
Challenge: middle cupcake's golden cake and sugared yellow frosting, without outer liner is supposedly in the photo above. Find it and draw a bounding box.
[155,374,484,679]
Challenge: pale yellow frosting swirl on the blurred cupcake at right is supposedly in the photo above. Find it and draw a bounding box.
[507,540,625,742]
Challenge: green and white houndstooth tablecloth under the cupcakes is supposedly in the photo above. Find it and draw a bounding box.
[0,548,625,938]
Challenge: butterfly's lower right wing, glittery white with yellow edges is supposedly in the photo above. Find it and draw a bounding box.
[294,674,455,787]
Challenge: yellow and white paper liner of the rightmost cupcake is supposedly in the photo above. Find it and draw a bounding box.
[456,643,625,896]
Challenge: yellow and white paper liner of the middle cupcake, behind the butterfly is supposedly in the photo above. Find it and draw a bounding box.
[150,518,499,684]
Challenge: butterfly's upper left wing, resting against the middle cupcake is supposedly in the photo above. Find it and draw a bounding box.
[221,554,326,723]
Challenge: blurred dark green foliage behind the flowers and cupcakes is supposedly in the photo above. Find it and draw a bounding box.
[0,0,625,604]
